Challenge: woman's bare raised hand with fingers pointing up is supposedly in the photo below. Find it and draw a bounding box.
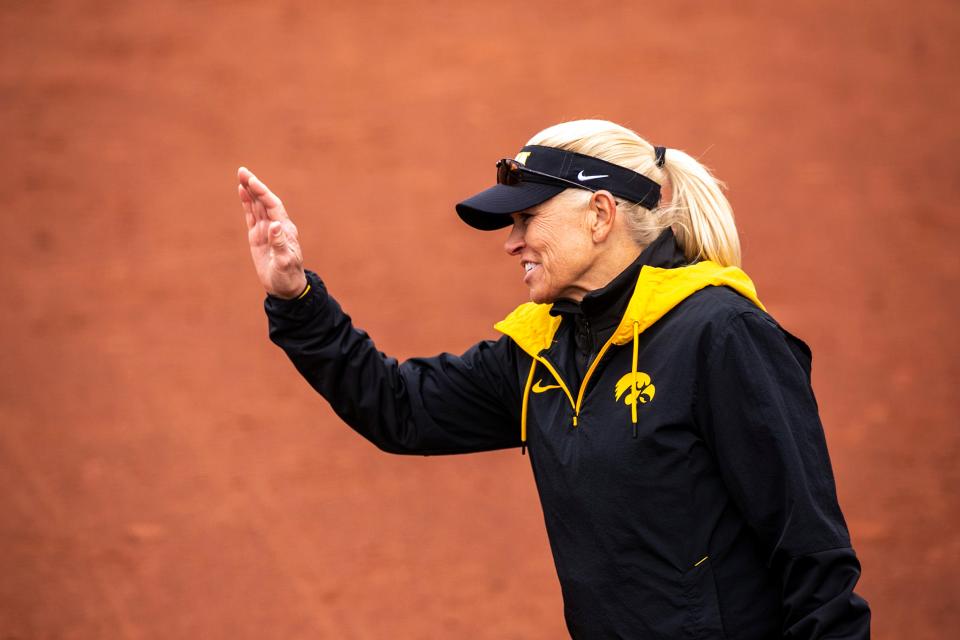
[237,167,307,299]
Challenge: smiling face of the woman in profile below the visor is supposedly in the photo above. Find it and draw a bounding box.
[504,190,594,303]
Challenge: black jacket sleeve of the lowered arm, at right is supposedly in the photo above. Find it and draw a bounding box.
[697,310,870,639]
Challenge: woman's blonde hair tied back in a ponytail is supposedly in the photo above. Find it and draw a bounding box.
[527,120,740,266]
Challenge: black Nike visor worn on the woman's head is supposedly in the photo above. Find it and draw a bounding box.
[457,145,660,231]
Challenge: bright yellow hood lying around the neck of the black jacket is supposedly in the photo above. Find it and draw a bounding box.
[494,260,764,358]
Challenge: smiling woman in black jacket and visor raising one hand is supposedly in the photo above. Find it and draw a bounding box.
[239,120,870,639]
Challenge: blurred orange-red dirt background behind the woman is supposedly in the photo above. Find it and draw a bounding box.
[0,0,960,640]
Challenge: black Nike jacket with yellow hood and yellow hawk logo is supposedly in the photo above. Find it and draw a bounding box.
[266,232,870,640]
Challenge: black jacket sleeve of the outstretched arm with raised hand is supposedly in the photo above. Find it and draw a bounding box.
[264,271,520,454]
